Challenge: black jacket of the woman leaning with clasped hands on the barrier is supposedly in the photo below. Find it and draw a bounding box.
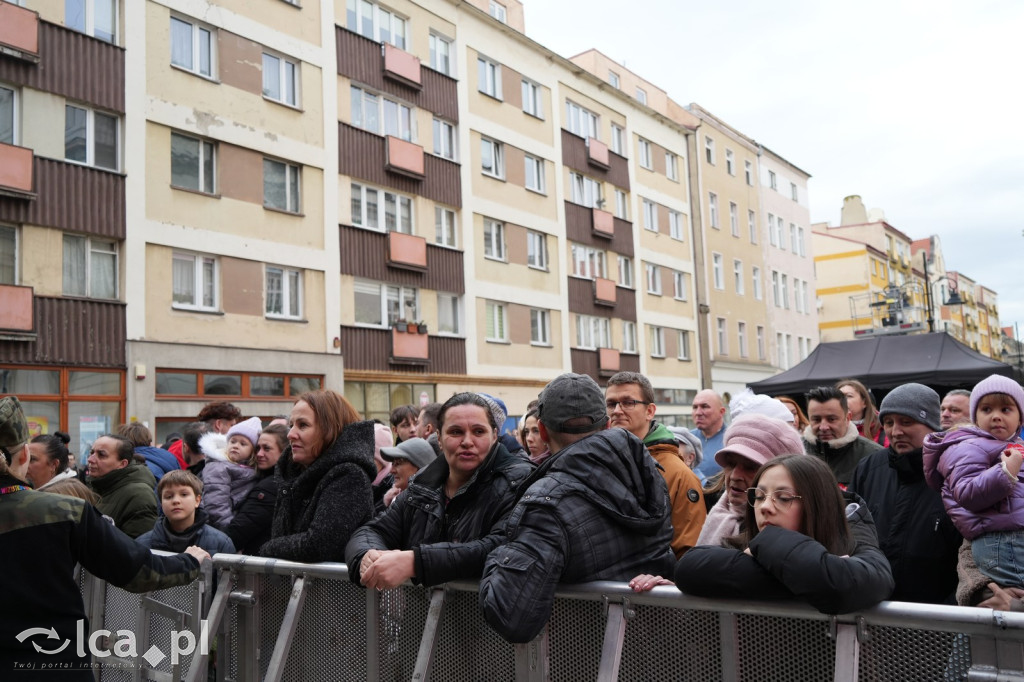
[345,442,534,585]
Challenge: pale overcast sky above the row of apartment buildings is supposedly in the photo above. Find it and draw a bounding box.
[524,0,1024,336]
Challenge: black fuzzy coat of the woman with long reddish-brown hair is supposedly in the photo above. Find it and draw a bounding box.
[259,422,377,563]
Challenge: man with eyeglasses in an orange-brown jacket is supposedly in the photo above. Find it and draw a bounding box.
[604,372,708,558]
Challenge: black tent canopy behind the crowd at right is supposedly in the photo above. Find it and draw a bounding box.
[750,333,1020,395]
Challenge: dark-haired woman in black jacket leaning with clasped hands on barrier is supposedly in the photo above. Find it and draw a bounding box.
[345,393,534,589]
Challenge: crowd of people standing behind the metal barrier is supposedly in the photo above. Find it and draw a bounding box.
[0,372,1024,667]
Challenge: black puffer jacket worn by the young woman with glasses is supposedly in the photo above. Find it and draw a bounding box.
[676,493,893,613]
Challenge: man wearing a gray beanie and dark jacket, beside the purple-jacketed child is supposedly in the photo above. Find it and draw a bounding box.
[849,384,963,604]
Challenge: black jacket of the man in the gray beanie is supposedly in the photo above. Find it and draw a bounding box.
[850,447,963,604]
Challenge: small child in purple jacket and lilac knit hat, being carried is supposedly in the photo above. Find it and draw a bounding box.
[925,374,1024,588]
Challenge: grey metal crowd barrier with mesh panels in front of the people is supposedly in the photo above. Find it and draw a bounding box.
[81,554,1024,682]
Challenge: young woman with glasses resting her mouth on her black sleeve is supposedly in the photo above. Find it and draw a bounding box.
[675,455,893,613]
